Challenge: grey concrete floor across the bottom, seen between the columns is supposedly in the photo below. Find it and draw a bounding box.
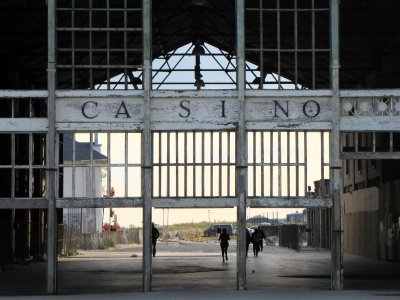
[0,239,400,297]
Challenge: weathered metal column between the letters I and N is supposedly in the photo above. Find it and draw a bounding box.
[236,0,247,290]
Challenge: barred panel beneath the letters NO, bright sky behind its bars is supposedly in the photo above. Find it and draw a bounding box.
[247,131,329,197]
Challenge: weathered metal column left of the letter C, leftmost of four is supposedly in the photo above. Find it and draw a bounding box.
[46,0,57,294]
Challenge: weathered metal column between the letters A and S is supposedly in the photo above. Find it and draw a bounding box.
[142,0,152,292]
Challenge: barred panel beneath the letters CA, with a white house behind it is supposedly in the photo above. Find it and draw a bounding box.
[59,132,141,198]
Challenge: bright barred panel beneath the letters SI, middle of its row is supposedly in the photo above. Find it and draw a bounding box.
[153,131,236,198]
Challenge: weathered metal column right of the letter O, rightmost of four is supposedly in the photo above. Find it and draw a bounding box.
[330,0,343,290]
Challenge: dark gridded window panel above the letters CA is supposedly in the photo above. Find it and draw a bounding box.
[56,0,142,90]
